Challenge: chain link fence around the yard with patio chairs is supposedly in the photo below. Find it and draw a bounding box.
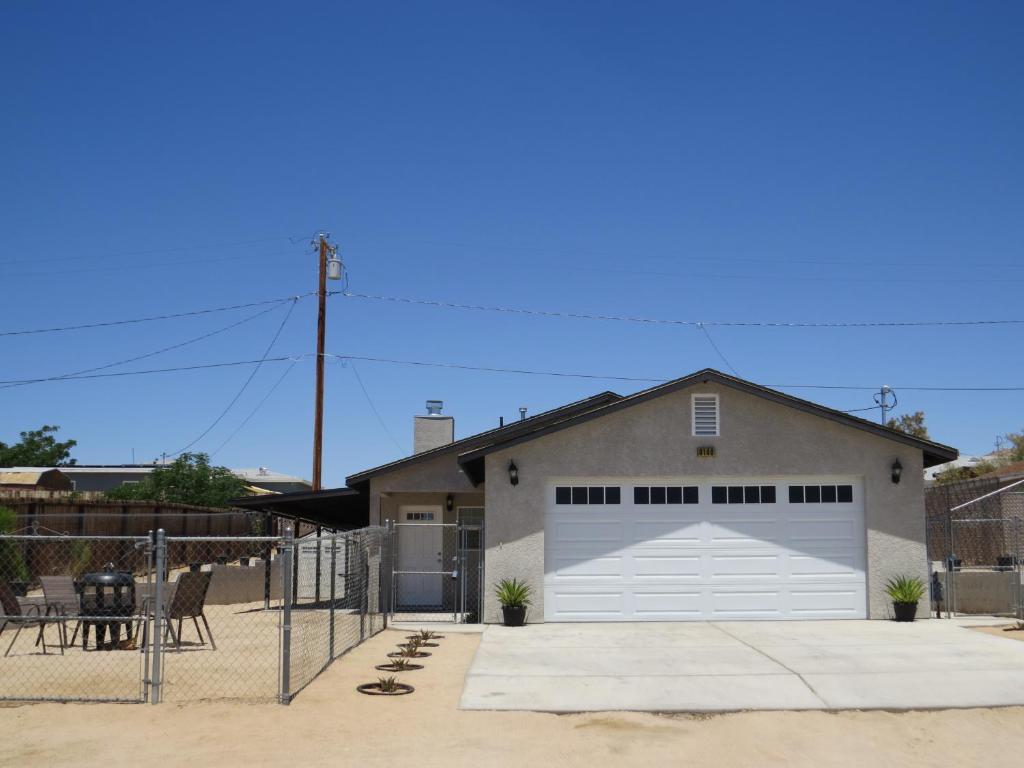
[0,527,390,703]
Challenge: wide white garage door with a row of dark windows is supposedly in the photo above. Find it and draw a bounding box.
[544,477,866,622]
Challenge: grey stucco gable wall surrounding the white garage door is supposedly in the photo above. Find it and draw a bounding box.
[484,384,928,622]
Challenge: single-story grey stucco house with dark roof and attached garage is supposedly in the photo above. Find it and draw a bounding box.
[347,369,957,622]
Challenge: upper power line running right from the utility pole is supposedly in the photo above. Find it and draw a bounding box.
[333,291,1024,328]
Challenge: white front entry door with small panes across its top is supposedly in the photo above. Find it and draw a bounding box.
[396,507,444,609]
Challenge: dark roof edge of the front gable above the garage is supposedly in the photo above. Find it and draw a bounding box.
[459,368,959,467]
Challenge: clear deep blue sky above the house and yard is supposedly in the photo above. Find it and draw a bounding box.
[0,2,1024,484]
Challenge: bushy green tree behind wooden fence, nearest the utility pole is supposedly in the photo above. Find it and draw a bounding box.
[105,454,246,507]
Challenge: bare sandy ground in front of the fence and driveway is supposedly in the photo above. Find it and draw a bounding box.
[0,631,1024,768]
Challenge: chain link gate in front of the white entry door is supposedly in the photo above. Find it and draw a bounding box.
[388,522,483,624]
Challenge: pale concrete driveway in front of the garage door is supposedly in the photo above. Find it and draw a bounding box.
[460,620,1024,712]
